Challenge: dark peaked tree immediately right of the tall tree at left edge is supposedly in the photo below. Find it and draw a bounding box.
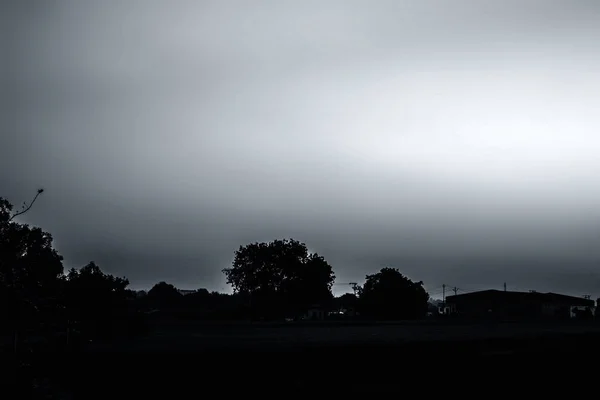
[65,261,130,336]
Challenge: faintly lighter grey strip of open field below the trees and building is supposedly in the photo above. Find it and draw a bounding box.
[113,321,600,353]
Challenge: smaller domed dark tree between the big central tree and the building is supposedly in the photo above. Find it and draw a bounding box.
[359,268,429,320]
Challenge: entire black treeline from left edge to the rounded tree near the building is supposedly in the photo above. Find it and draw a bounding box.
[0,190,429,349]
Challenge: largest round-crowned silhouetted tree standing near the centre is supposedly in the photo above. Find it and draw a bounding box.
[223,239,335,317]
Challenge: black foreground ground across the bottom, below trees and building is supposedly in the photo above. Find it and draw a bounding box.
[2,324,600,399]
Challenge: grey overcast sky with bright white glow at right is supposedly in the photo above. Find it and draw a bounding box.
[0,0,600,296]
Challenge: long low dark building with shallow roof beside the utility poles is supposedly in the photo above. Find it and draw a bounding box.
[446,290,595,319]
